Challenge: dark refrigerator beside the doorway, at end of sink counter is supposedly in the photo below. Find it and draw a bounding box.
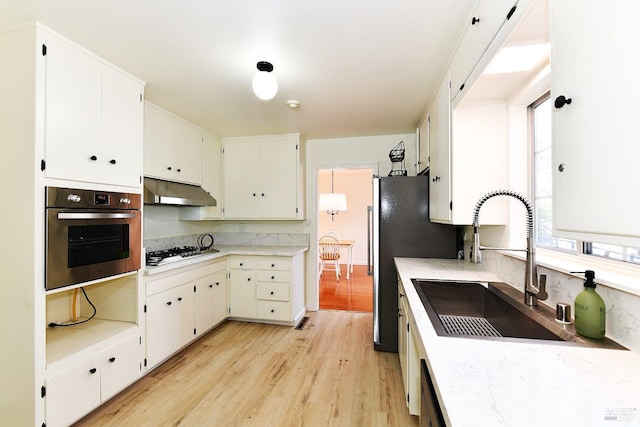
[370,174,460,352]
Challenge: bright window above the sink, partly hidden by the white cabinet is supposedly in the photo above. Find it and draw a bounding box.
[528,92,640,264]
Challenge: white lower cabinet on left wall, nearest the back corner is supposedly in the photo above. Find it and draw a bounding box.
[196,261,228,336]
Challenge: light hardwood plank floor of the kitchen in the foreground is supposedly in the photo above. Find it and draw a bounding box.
[77,311,418,427]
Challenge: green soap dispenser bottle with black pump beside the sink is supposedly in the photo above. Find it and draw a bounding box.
[575,270,607,339]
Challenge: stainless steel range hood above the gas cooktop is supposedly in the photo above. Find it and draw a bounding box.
[144,178,217,206]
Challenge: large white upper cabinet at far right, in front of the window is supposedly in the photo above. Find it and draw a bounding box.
[550,0,640,247]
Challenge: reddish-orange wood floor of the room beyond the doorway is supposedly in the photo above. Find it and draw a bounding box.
[320,265,373,313]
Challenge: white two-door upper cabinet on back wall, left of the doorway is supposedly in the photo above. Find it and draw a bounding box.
[223,134,304,219]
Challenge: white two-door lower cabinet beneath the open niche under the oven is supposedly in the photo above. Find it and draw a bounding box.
[45,335,142,427]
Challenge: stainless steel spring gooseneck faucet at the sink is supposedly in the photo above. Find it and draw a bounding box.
[471,190,548,305]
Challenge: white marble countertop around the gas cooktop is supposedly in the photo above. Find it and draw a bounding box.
[144,245,309,276]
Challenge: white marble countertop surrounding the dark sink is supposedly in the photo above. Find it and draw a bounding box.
[395,258,640,427]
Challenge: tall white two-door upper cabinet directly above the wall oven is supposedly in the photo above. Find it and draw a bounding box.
[43,36,143,187]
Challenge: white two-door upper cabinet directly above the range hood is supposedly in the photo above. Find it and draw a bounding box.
[144,102,203,185]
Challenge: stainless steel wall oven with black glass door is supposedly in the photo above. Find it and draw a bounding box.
[45,187,142,290]
